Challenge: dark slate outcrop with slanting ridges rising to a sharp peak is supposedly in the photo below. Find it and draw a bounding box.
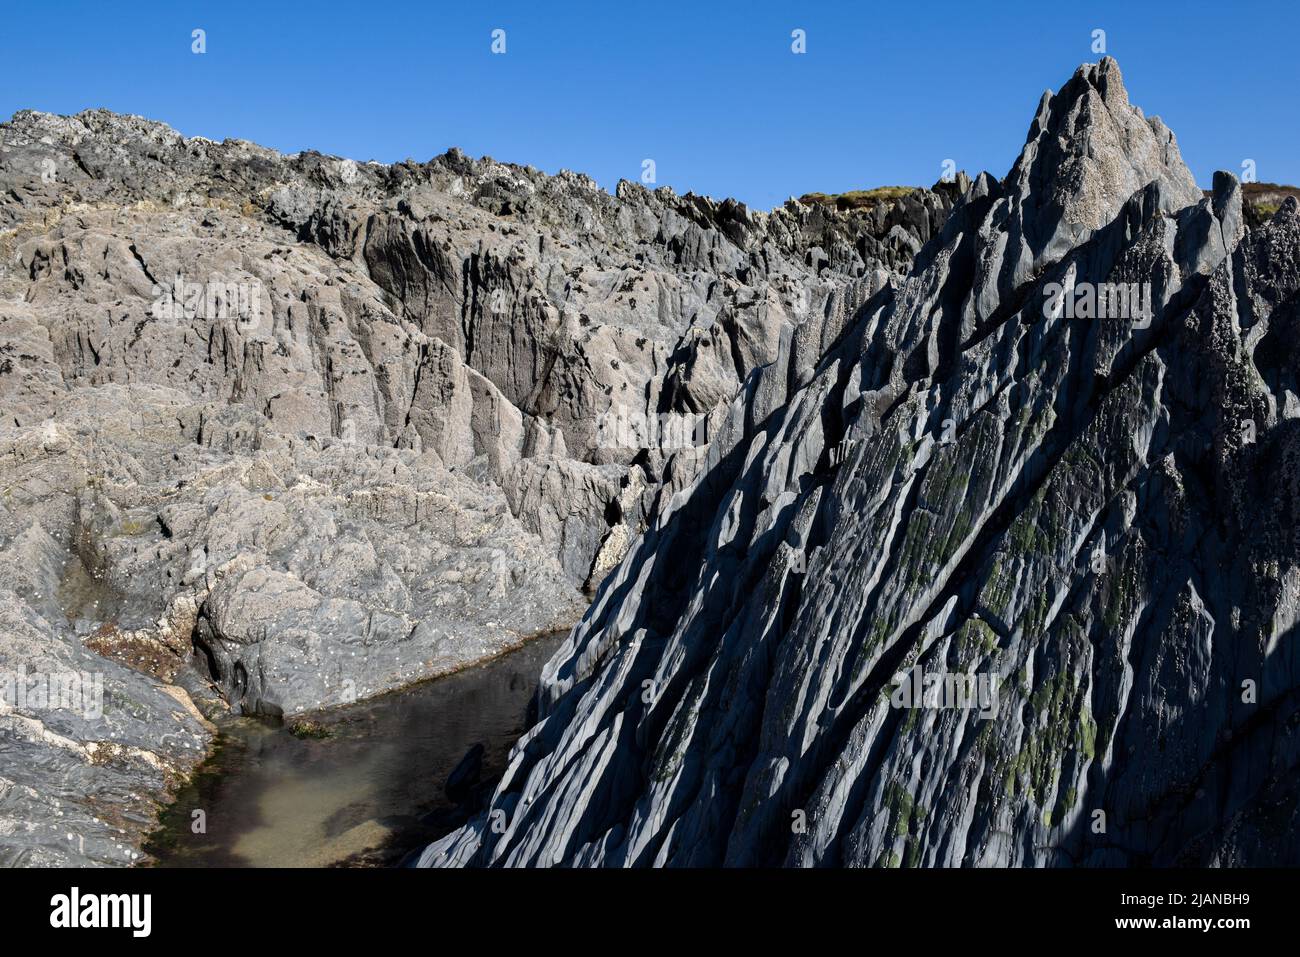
[421,60,1300,866]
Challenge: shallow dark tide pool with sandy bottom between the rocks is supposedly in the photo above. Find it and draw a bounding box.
[146,635,563,867]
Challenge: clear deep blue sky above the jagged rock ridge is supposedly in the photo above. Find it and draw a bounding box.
[0,0,1300,208]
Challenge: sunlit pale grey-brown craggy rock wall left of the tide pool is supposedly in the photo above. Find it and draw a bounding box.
[0,100,962,862]
